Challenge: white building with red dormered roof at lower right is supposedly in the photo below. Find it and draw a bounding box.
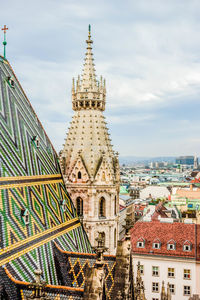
[131,217,200,300]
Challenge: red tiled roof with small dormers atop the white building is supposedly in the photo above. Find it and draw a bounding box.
[131,221,200,260]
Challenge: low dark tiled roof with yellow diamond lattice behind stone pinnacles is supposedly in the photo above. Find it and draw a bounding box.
[0,243,116,300]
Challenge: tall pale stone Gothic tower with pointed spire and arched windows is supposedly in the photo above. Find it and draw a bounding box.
[60,26,119,254]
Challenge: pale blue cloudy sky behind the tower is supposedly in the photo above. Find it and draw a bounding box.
[0,0,200,156]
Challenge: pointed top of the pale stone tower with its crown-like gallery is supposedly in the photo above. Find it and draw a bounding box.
[72,25,106,111]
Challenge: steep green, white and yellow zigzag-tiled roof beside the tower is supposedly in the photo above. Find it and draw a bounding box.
[0,57,92,290]
